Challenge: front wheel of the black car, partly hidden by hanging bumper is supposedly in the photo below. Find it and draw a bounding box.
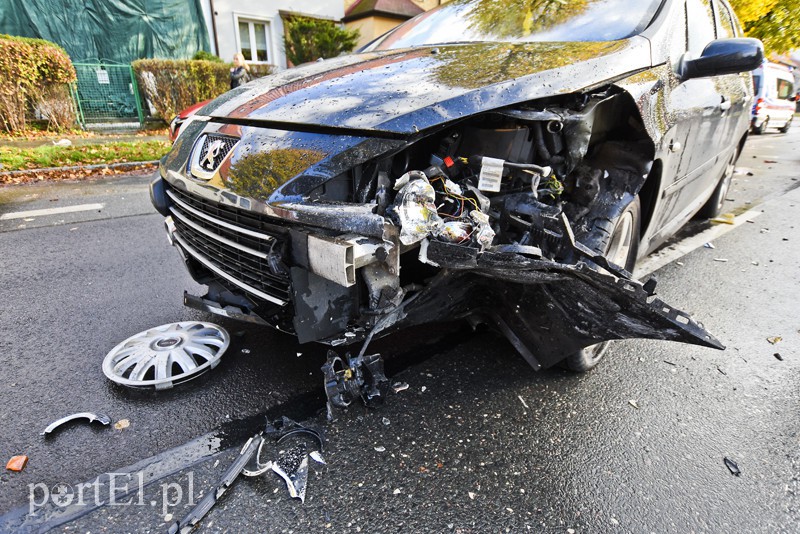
[561,196,642,373]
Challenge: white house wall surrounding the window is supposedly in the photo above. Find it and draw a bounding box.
[202,0,344,68]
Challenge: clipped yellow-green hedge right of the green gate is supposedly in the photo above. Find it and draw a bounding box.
[133,59,271,122]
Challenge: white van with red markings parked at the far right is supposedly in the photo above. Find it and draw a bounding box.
[750,61,797,134]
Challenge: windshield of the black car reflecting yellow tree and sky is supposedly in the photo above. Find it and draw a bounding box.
[363,0,661,51]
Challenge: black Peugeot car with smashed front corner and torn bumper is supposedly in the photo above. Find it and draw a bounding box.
[151,0,763,371]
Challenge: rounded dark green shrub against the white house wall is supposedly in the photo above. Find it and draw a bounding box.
[283,16,359,65]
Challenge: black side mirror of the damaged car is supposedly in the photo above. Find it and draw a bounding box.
[681,38,764,80]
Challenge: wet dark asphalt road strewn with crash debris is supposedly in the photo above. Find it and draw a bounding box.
[0,128,800,532]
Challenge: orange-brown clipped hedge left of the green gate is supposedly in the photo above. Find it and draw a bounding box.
[0,35,76,132]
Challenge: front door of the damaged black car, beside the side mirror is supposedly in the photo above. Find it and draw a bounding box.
[655,0,738,235]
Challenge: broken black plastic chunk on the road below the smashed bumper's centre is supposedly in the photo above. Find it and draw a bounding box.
[322,350,389,419]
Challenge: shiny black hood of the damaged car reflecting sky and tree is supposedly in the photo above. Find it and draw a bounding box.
[203,36,651,135]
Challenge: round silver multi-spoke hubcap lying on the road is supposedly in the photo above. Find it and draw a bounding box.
[103,321,230,390]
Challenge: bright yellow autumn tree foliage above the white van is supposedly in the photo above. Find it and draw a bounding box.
[730,0,800,54]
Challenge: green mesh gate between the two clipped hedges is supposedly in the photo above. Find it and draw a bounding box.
[73,62,144,127]
